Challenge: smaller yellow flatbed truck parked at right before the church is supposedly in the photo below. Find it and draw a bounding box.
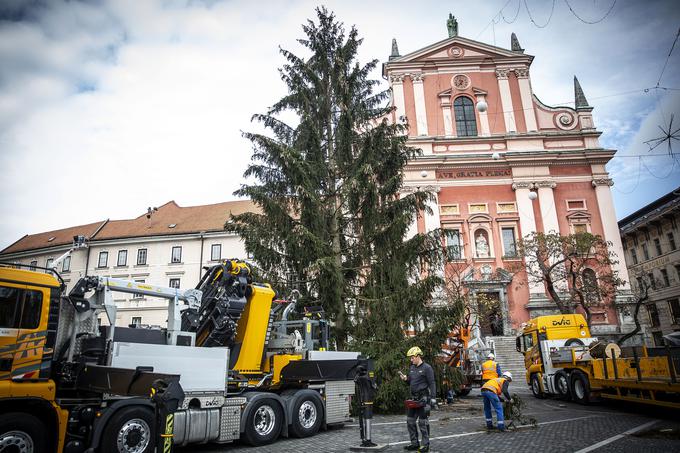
[517,314,680,408]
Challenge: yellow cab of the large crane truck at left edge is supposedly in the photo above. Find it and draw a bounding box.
[0,267,68,451]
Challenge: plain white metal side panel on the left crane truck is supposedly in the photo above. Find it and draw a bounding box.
[111,342,229,392]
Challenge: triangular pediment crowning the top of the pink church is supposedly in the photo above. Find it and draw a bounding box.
[389,36,533,64]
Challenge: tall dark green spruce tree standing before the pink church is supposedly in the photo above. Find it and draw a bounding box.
[225,8,460,408]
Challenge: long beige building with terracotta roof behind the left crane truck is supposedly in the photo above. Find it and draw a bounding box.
[0,201,255,327]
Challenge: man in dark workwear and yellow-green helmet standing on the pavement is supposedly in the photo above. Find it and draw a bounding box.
[399,346,437,452]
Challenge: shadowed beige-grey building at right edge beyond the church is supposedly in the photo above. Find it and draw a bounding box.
[619,188,680,346]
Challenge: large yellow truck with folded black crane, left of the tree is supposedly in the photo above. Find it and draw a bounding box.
[0,260,372,453]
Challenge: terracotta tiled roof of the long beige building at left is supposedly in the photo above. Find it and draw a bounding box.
[0,200,260,254]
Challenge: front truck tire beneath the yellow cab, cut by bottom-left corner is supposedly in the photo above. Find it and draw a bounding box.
[0,412,48,453]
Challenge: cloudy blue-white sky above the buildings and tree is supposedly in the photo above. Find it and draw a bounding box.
[0,0,680,248]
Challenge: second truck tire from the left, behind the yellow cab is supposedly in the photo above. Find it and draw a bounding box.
[101,406,156,453]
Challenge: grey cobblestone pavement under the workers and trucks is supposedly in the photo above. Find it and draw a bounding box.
[179,389,680,453]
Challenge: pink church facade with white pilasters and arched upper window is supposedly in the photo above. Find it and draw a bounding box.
[383,24,632,335]
